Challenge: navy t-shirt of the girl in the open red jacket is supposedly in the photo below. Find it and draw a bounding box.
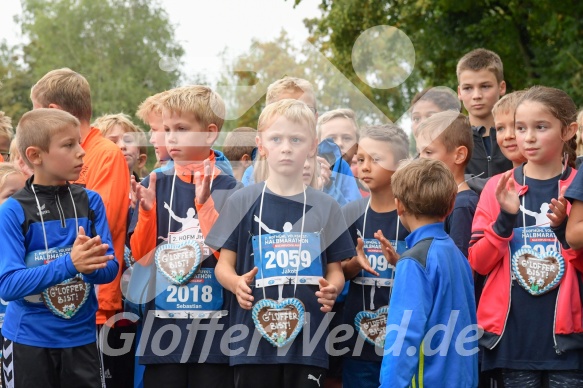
[482,165,581,370]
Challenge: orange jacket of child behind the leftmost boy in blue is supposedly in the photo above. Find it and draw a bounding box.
[74,128,130,325]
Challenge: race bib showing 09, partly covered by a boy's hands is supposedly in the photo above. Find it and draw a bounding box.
[352,238,407,287]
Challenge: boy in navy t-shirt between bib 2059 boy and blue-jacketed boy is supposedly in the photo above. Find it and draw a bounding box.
[342,124,409,388]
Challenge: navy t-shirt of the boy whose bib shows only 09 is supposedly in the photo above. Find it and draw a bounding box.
[342,198,409,362]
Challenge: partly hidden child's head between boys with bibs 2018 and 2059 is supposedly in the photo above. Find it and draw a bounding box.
[223,127,257,182]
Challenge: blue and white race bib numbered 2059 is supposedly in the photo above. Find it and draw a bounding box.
[252,232,323,287]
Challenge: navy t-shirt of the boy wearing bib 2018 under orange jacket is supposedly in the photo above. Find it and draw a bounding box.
[129,169,240,364]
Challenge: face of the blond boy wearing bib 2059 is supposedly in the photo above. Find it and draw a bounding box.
[257,116,317,178]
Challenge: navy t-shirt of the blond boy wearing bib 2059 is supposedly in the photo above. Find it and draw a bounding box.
[205,182,356,368]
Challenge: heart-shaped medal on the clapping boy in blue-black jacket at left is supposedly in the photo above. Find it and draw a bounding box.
[42,277,91,319]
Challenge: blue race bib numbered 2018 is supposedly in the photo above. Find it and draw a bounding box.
[155,268,227,319]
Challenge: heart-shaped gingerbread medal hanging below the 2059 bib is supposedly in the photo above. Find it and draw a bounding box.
[252,298,306,348]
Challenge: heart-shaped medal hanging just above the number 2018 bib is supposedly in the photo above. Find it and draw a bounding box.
[154,240,202,285]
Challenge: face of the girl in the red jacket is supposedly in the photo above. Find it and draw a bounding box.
[515,101,569,165]
